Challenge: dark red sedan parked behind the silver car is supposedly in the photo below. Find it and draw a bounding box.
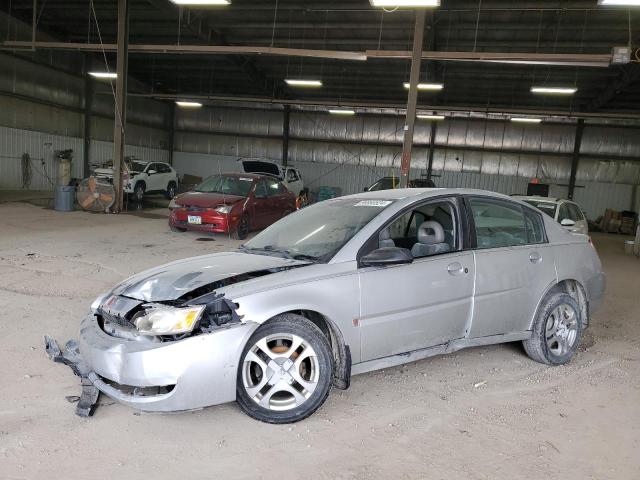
[169,173,296,239]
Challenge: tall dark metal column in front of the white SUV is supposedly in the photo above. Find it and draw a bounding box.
[113,0,129,212]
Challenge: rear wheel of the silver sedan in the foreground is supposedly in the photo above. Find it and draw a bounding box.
[522,293,583,365]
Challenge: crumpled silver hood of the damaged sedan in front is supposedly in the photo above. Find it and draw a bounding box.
[111,252,308,302]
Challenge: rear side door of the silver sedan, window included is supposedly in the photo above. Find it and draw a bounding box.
[467,196,555,338]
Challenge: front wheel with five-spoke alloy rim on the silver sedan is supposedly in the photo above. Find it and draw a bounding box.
[236,313,333,423]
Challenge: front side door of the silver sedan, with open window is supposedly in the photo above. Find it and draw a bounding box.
[358,198,474,361]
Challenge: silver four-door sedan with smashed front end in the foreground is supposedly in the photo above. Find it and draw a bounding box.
[46,189,605,423]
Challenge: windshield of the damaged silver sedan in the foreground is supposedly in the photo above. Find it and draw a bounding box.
[241,198,393,261]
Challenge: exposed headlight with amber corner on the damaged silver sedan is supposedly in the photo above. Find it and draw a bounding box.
[133,304,206,335]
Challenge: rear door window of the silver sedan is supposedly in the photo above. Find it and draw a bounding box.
[469,197,529,248]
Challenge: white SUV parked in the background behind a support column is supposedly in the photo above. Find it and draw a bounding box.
[93,160,178,202]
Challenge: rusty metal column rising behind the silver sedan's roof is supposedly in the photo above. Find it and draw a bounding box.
[400,10,426,188]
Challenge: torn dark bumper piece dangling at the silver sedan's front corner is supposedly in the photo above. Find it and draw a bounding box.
[44,335,100,417]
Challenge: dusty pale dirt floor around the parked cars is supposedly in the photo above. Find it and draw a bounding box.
[0,203,640,480]
